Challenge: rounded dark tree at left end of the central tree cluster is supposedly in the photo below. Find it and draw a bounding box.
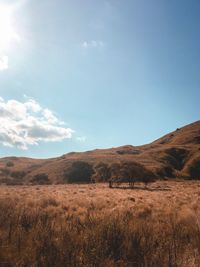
[64,161,94,183]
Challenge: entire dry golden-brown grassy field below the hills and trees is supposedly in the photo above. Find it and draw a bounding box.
[0,181,200,267]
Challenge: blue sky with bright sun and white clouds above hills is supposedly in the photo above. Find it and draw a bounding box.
[0,0,200,158]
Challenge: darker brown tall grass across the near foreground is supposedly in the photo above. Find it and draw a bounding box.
[0,199,200,267]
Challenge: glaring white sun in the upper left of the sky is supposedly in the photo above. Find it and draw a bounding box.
[0,6,19,50]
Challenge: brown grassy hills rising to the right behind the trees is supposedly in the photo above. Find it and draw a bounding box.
[0,121,200,184]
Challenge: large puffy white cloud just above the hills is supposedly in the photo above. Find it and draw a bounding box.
[0,97,74,149]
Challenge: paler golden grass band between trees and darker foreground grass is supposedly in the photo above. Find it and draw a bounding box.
[0,181,200,215]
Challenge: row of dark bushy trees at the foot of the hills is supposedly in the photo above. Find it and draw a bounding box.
[64,161,154,188]
